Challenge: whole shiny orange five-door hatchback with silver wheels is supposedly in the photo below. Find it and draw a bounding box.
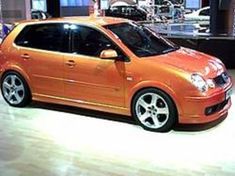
[0,17,232,132]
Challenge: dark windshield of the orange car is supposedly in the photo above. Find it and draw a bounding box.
[105,22,179,57]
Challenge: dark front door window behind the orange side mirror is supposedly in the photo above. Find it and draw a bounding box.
[71,25,124,57]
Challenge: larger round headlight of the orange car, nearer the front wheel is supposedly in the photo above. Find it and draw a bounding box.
[191,73,208,92]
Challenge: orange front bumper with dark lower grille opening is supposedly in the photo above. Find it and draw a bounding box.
[179,83,232,124]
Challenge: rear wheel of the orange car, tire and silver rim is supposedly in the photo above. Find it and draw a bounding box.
[1,72,31,107]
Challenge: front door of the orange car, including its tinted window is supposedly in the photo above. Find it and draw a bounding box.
[65,25,125,107]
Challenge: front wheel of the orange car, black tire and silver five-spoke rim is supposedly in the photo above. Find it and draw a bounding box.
[131,88,178,132]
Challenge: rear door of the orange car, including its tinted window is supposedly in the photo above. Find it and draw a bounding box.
[15,23,69,97]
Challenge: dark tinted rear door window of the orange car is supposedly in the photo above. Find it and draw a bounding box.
[15,23,69,52]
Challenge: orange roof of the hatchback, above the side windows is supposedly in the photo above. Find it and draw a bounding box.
[18,16,130,26]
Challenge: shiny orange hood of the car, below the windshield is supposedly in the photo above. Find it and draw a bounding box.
[142,48,225,78]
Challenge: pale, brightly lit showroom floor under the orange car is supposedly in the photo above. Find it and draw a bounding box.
[0,70,235,176]
